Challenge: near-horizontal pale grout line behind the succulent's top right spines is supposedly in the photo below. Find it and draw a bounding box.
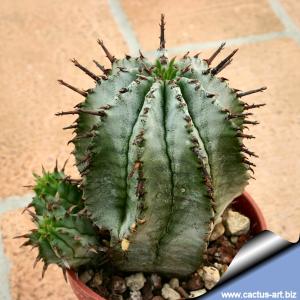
[145,32,288,56]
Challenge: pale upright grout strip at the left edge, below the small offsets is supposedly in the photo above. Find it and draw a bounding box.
[0,233,11,300]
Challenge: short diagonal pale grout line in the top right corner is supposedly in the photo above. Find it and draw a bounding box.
[268,0,300,43]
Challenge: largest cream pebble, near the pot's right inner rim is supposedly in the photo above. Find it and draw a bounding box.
[224,209,250,235]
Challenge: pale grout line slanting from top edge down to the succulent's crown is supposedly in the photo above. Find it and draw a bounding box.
[108,0,141,55]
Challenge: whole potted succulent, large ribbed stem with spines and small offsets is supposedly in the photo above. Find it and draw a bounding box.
[19,15,265,275]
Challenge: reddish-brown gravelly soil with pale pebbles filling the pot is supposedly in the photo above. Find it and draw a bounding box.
[78,206,253,300]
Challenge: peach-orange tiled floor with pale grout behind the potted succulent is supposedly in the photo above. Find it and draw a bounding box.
[0,0,300,300]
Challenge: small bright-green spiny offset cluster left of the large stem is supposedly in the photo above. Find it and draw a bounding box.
[21,168,103,271]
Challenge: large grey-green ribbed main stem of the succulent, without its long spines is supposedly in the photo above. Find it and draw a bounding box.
[71,57,249,275]
